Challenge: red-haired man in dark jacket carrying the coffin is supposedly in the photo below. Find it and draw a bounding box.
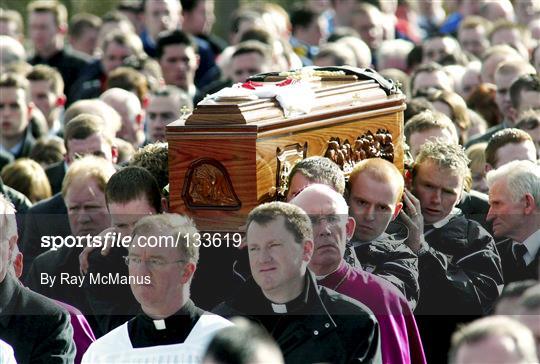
[345,158,419,309]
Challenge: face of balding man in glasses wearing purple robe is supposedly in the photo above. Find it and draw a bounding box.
[293,191,355,275]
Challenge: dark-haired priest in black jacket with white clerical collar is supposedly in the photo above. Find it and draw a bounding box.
[215,202,380,363]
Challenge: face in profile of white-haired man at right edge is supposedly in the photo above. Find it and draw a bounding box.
[487,178,524,238]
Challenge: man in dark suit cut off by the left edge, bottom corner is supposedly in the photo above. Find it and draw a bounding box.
[0,195,75,364]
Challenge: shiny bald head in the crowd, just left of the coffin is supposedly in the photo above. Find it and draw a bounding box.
[99,88,145,148]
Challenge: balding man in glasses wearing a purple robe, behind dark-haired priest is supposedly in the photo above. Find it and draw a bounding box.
[291,184,426,364]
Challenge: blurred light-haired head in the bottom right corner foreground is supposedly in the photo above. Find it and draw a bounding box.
[448,316,538,364]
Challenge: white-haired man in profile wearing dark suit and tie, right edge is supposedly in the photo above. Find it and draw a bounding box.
[486,160,540,283]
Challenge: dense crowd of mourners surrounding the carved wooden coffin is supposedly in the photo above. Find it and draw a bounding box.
[0,0,540,364]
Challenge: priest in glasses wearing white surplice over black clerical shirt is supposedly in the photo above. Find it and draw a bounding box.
[82,214,232,363]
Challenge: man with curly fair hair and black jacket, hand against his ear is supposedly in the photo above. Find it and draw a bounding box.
[412,141,503,363]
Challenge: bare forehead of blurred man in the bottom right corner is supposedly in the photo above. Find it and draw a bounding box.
[455,335,524,364]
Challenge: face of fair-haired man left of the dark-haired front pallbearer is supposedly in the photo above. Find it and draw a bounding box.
[64,177,111,236]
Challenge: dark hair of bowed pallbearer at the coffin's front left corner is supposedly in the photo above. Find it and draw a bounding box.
[105,166,161,212]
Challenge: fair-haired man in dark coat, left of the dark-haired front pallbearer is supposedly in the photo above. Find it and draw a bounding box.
[28,156,115,313]
